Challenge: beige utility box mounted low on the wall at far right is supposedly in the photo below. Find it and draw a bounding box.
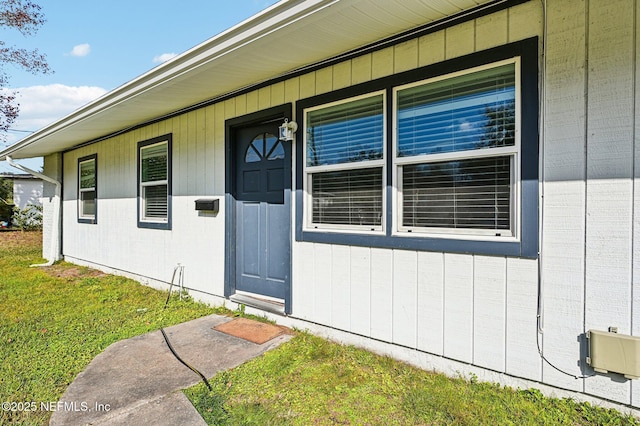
[587,330,640,379]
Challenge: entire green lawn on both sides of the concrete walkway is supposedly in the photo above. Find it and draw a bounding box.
[0,232,640,425]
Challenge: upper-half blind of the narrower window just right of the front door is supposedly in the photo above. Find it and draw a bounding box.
[306,94,384,166]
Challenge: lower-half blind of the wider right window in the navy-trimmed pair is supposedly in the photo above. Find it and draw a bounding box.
[402,156,511,230]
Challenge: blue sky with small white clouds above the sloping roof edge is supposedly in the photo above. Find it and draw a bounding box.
[0,0,276,173]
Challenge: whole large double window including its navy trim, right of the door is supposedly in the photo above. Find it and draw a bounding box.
[296,38,539,258]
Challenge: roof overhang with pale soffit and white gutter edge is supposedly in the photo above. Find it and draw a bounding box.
[0,0,496,160]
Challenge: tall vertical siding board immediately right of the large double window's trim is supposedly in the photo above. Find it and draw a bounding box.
[541,0,586,390]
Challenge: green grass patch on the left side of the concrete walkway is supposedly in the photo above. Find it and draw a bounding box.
[0,231,220,425]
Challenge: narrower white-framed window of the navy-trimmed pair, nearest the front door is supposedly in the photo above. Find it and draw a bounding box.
[304,92,385,231]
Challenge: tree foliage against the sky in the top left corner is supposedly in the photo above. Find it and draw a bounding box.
[0,0,51,139]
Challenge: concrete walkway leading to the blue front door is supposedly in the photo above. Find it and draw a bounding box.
[50,315,291,426]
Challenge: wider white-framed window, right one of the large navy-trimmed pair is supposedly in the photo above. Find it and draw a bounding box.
[394,60,520,237]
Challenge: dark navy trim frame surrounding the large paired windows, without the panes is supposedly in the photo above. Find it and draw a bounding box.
[295,37,539,258]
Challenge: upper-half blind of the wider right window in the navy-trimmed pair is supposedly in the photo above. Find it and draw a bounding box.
[397,64,516,157]
